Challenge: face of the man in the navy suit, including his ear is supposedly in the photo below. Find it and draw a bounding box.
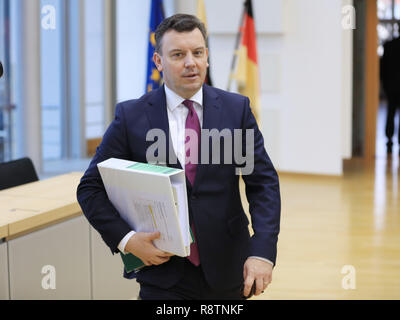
[153,28,208,99]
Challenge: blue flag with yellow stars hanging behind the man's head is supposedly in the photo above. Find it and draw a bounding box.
[146,0,164,92]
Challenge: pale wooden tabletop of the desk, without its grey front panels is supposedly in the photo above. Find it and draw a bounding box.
[0,172,83,238]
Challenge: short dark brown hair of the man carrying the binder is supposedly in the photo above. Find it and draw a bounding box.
[155,13,207,54]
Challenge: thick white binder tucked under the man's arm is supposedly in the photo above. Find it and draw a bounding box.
[97,158,192,257]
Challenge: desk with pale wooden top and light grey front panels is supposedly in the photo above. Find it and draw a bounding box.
[0,172,139,300]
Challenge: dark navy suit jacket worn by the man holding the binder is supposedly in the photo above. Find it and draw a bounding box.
[77,85,280,290]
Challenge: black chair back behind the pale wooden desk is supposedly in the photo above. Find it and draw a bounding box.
[0,158,39,190]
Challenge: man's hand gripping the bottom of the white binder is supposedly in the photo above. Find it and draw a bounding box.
[125,231,173,266]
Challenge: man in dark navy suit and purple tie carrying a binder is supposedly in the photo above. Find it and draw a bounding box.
[77,14,280,299]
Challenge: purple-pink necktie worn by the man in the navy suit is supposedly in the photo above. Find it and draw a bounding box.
[183,100,200,266]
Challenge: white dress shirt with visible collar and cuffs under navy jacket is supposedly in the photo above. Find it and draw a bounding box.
[118,85,273,265]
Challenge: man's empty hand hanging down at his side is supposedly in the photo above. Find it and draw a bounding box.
[243,258,272,297]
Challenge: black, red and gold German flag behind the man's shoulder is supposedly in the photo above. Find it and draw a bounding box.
[228,0,260,122]
